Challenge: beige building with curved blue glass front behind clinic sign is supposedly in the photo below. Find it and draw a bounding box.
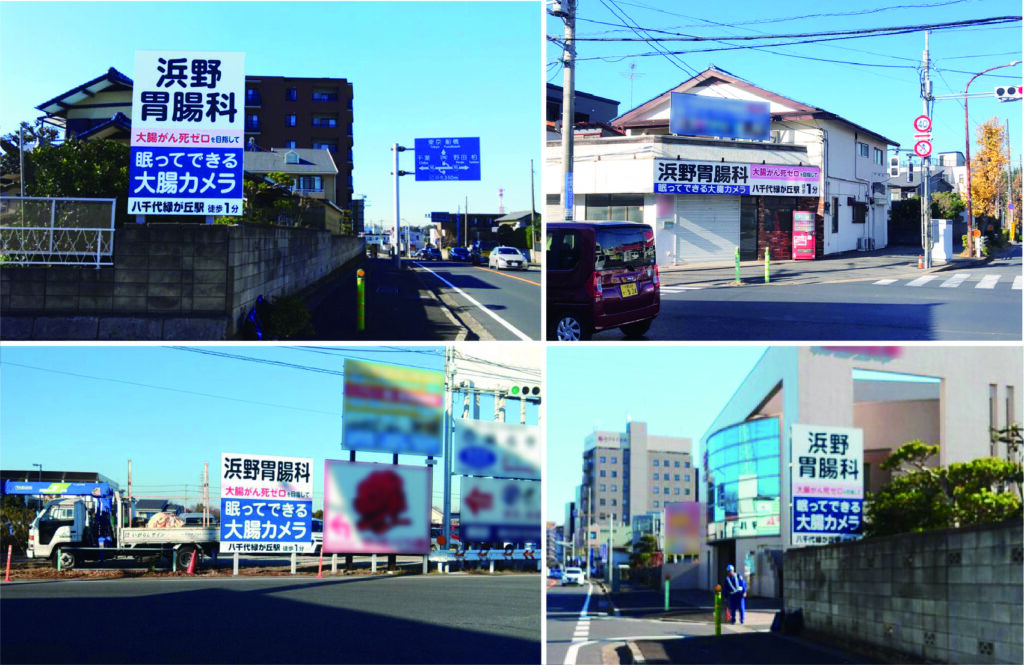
[691,346,1024,597]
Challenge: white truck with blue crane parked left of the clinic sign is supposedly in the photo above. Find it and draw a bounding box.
[4,481,220,570]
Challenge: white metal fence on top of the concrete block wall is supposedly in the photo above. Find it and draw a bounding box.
[0,197,117,267]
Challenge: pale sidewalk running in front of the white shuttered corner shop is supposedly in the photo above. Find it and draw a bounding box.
[659,240,1021,287]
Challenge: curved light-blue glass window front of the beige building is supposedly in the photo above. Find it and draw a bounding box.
[706,418,780,541]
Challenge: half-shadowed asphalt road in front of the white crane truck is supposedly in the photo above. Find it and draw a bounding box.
[0,575,541,663]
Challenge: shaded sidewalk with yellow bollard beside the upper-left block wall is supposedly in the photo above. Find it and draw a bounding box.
[305,258,474,341]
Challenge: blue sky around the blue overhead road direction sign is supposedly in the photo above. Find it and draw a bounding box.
[0,1,543,224]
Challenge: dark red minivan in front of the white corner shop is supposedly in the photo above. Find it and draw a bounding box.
[545,221,662,341]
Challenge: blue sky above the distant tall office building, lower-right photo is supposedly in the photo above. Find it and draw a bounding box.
[544,344,765,524]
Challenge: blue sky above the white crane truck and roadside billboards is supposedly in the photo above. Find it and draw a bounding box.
[0,345,537,514]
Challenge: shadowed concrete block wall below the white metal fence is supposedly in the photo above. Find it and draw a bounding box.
[0,223,364,340]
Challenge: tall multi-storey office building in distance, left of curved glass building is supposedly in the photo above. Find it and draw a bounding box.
[575,422,697,547]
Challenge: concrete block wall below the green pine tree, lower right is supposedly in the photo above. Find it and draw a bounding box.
[783,522,1024,663]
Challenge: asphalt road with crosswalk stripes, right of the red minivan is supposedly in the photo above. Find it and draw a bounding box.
[594,256,1022,341]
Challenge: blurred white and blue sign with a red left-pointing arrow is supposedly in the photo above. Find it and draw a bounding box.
[459,477,541,543]
